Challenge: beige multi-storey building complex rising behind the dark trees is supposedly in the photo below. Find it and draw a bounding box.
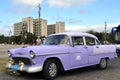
[14,17,65,37]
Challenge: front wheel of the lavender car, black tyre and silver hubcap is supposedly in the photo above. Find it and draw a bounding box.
[43,60,58,80]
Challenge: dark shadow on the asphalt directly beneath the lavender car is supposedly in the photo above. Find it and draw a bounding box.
[5,66,97,80]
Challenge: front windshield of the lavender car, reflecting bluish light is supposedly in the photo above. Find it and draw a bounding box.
[43,35,69,45]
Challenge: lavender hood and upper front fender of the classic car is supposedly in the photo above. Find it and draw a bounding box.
[9,45,69,57]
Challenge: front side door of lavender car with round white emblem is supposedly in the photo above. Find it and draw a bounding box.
[70,36,88,68]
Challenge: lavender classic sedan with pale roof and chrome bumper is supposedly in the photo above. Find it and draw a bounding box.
[6,32,116,80]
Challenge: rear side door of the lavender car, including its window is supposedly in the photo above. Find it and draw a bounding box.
[85,37,101,65]
